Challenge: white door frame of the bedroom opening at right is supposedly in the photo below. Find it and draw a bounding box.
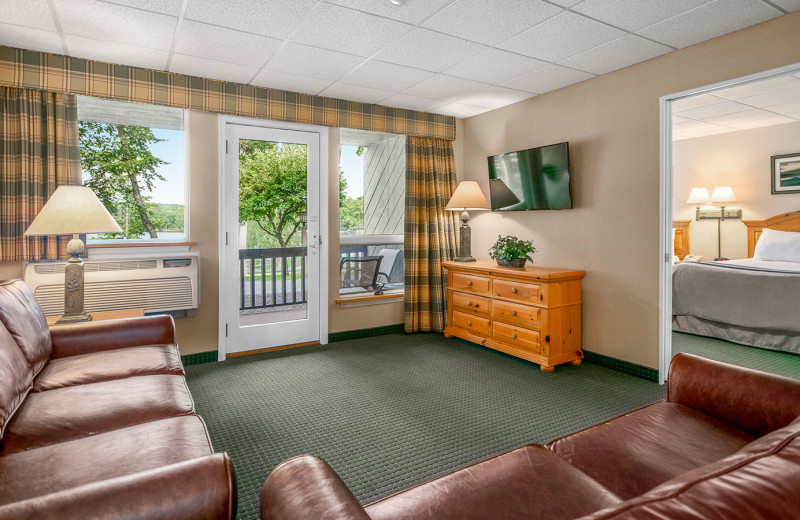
[658,63,800,384]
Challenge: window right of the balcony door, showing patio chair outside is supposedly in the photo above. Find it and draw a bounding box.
[339,129,406,294]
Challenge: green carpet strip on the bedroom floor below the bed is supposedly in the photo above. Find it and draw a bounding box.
[672,332,800,379]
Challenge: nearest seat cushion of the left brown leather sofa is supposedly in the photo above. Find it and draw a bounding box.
[0,415,212,504]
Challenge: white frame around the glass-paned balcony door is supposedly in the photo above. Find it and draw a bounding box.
[217,114,330,361]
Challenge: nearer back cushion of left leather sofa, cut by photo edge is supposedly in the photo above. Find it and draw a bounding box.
[0,323,31,439]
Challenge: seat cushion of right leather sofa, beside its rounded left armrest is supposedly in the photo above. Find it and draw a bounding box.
[366,445,620,520]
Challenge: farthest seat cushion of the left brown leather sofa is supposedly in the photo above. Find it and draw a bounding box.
[33,345,183,392]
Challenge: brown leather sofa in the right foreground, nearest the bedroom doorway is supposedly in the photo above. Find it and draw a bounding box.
[261,354,800,520]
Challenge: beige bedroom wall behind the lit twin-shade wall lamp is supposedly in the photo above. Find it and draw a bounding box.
[672,123,800,260]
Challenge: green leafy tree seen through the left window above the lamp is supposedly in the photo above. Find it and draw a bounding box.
[78,121,168,238]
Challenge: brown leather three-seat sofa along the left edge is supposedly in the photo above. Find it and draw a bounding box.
[0,280,236,520]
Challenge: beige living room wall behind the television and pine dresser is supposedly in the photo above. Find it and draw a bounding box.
[462,13,800,367]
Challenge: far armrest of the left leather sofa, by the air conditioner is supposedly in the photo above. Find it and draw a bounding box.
[50,314,175,359]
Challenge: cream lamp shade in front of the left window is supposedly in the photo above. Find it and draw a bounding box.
[25,186,122,236]
